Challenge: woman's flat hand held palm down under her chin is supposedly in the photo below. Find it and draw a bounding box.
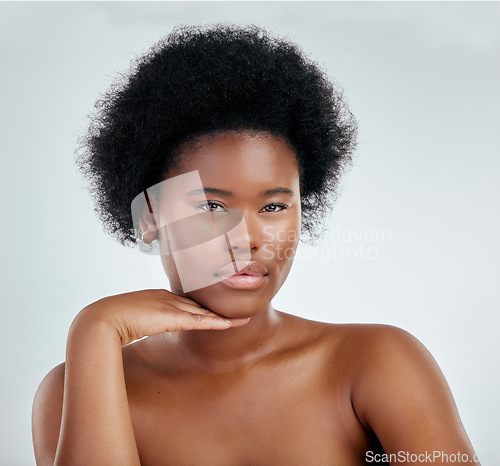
[73,289,250,346]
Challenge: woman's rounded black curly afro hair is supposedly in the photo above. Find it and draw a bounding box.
[76,24,357,245]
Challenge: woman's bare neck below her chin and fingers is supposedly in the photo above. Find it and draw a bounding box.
[177,303,282,372]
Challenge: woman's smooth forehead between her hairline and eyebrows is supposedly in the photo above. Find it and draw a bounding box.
[166,133,299,190]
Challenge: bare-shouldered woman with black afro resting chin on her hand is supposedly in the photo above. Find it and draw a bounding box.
[33,26,479,466]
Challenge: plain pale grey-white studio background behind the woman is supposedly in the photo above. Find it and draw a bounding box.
[0,2,500,466]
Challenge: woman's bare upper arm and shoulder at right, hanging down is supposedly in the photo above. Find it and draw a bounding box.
[353,326,478,464]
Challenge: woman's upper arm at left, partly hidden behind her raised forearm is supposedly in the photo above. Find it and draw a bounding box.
[32,364,64,466]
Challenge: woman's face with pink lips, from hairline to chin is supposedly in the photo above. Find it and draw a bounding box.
[154,132,301,318]
